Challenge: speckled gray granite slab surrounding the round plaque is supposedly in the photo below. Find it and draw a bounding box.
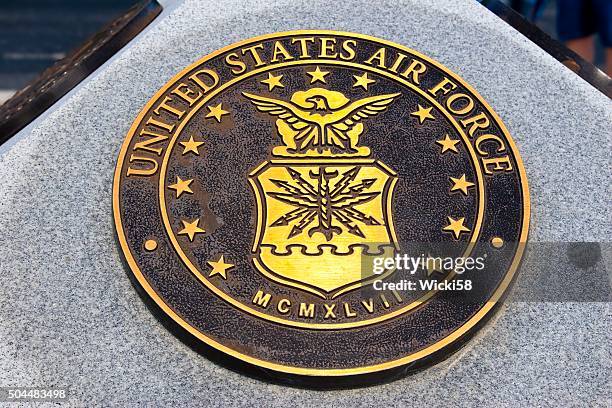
[0,0,612,407]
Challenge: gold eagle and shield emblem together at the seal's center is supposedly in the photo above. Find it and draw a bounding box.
[242,88,400,298]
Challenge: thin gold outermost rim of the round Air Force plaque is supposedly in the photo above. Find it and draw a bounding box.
[113,30,531,376]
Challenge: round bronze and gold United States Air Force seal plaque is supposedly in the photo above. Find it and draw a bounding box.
[113,31,529,384]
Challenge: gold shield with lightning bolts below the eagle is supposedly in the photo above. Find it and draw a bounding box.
[249,159,399,299]
